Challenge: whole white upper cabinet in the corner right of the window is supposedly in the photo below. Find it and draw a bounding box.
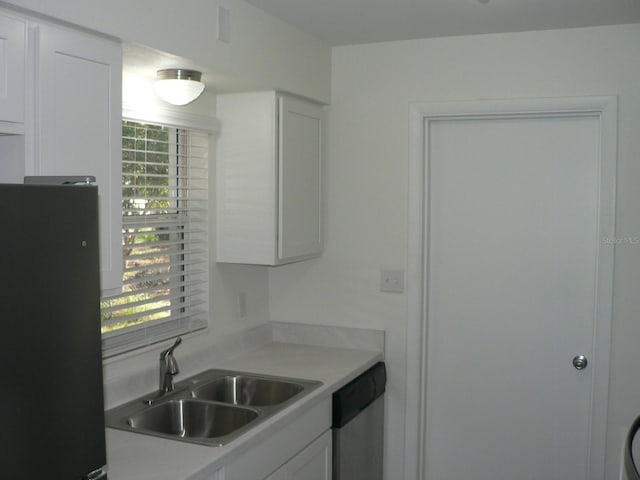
[216,92,323,265]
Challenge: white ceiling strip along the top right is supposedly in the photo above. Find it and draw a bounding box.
[247,0,640,46]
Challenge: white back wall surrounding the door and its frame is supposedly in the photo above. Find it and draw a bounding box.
[269,25,640,479]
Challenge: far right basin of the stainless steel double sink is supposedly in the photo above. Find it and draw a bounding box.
[193,375,304,406]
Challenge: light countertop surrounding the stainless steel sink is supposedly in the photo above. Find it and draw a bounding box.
[106,342,383,480]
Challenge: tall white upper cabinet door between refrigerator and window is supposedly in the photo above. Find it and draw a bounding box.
[33,24,122,290]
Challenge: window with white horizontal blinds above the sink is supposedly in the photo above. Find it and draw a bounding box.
[102,121,209,353]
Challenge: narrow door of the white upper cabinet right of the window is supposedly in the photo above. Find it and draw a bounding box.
[278,96,322,261]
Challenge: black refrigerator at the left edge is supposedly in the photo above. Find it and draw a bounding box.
[0,184,107,480]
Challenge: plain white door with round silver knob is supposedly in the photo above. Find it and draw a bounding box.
[423,99,611,480]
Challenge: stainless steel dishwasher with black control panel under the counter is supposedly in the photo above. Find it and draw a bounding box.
[332,362,387,480]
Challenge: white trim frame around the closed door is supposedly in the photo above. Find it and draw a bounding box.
[404,96,618,480]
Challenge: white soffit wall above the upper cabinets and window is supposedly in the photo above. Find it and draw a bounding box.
[0,0,331,101]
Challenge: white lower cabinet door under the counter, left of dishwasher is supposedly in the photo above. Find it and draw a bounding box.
[265,430,331,480]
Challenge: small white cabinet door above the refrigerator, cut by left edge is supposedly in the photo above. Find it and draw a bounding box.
[0,15,25,129]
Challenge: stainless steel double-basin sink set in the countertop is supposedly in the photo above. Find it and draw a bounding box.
[105,370,321,446]
